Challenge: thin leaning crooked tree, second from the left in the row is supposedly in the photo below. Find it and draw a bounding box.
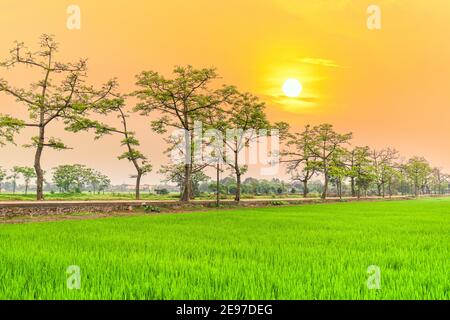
[68,94,152,200]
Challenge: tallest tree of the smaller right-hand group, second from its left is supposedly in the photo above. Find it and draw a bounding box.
[306,124,352,199]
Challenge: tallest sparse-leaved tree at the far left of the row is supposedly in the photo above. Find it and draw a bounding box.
[0,35,116,200]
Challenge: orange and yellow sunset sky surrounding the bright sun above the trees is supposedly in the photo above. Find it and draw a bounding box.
[0,0,450,183]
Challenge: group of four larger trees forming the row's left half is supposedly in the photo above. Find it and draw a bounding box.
[0,35,284,201]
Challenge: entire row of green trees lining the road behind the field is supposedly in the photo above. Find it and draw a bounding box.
[0,35,447,201]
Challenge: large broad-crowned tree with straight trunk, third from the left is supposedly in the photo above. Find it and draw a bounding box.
[135,66,235,201]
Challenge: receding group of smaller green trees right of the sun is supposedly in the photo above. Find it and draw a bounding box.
[282,124,450,198]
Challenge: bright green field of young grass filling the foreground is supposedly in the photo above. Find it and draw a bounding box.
[0,199,450,299]
